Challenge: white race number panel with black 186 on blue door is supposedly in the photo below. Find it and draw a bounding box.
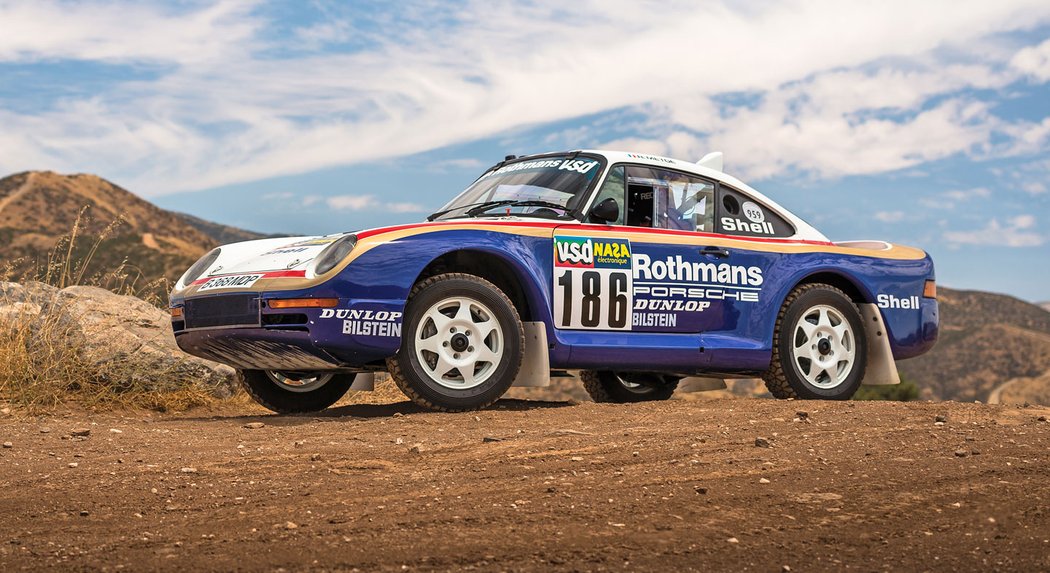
[554,268,633,331]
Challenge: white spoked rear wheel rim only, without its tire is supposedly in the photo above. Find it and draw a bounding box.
[792,304,857,389]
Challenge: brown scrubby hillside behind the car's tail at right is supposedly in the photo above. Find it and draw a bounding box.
[898,288,1050,403]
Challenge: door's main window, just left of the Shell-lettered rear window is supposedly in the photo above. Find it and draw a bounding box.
[626,166,715,233]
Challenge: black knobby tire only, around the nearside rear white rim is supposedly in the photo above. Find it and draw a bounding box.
[762,283,867,400]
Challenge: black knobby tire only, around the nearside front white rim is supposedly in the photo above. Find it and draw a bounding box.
[386,273,525,411]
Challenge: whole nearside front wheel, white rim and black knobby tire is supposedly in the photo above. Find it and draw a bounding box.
[386,273,525,411]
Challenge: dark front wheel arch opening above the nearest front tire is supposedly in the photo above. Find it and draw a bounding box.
[414,248,542,321]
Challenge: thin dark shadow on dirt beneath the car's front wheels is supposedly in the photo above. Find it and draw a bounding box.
[181,399,578,426]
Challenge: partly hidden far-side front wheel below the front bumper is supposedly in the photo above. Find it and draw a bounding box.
[237,370,357,413]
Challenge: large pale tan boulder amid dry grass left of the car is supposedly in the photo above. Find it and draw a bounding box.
[0,282,235,398]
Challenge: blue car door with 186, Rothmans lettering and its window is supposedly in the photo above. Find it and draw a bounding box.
[552,165,762,333]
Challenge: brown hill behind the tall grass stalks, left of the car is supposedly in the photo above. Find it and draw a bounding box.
[0,171,263,294]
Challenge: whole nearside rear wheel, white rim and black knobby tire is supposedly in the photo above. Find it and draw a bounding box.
[762,284,867,400]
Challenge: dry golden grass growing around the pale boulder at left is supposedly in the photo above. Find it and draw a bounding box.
[0,211,216,411]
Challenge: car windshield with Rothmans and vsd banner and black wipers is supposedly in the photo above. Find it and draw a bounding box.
[436,155,602,218]
